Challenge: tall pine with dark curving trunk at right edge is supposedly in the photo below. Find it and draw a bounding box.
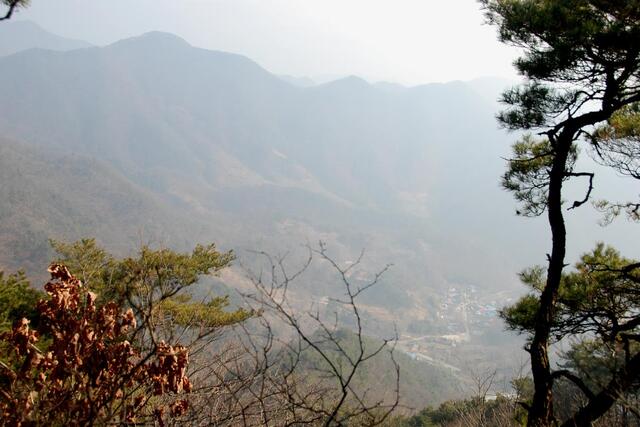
[480,0,640,426]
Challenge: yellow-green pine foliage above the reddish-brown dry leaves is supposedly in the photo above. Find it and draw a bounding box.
[51,239,252,329]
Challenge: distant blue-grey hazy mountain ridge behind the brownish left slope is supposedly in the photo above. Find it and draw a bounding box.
[0,26,540,302]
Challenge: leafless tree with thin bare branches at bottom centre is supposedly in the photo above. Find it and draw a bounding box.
[181,244,400,426]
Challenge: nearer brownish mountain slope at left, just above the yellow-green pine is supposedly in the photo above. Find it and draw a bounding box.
[0,138,215,279]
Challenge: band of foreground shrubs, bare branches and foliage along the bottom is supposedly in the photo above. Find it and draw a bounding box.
[0,240,640,427]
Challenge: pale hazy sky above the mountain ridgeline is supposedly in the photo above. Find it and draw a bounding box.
[17,0,516,84]
